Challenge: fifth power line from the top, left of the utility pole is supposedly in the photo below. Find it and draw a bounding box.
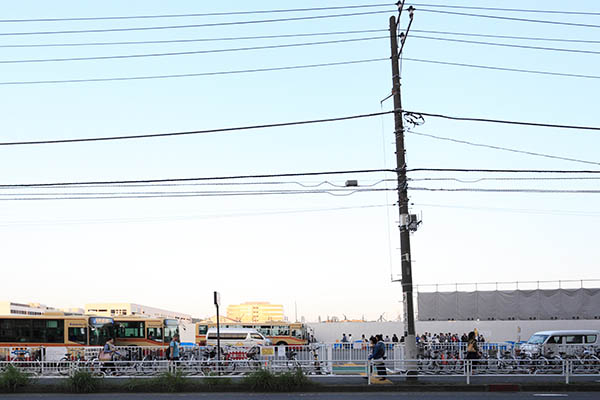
[0,58,390,86]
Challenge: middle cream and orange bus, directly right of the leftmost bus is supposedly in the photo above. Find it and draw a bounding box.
[114,316,179,346]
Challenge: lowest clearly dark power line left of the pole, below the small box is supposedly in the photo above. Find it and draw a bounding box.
[0,188,396,201]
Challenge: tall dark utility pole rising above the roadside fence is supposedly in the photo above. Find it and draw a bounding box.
[390,16,417,360]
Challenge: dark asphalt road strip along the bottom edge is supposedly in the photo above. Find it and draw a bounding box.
[0,392,600,400]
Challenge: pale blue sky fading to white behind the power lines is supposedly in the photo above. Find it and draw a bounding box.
[0,0,600,321]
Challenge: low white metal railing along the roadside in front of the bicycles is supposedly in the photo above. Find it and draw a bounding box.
[0,359,600,384]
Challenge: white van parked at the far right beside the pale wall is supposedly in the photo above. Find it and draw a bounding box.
[520,330,600,355]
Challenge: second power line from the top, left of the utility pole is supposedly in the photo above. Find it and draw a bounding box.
[0,11,390,36]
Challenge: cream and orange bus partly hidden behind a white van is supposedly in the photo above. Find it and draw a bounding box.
[196,321,308,346]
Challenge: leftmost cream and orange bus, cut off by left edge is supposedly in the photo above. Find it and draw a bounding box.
[0,314,114,347]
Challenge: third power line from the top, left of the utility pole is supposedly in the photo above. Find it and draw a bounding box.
[0,29,387,48]
